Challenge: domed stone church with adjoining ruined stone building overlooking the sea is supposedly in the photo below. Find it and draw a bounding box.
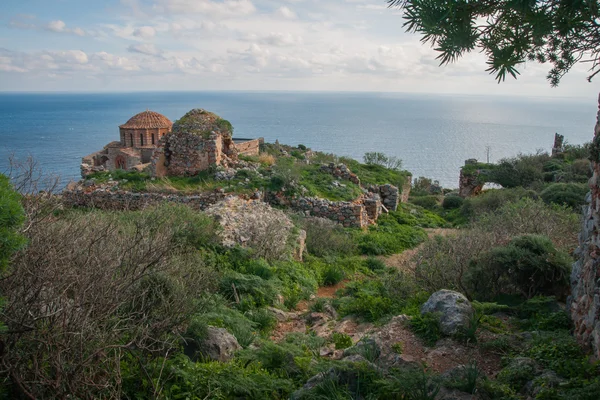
[81,109,263,177]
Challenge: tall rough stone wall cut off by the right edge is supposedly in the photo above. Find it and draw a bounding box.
[568,97,600,360]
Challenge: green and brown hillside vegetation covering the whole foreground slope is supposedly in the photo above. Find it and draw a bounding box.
[0,147,600,400]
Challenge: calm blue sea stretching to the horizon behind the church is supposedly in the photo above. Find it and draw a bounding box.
[0,92,597,187]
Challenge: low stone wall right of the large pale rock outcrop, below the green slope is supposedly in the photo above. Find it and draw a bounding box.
[290,197,370,228]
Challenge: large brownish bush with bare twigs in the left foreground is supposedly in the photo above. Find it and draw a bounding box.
[0,209,216,398]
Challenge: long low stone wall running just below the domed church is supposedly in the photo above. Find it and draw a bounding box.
[62,188,227,211]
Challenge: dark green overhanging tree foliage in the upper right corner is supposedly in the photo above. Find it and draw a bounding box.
[387,0,600,86]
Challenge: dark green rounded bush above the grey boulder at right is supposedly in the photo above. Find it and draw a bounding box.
[465,235,572,299]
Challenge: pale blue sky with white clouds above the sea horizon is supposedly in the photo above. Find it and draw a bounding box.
[0,0,600,98]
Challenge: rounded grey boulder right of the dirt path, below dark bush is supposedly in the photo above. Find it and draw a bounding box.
[421,289,475,336]
